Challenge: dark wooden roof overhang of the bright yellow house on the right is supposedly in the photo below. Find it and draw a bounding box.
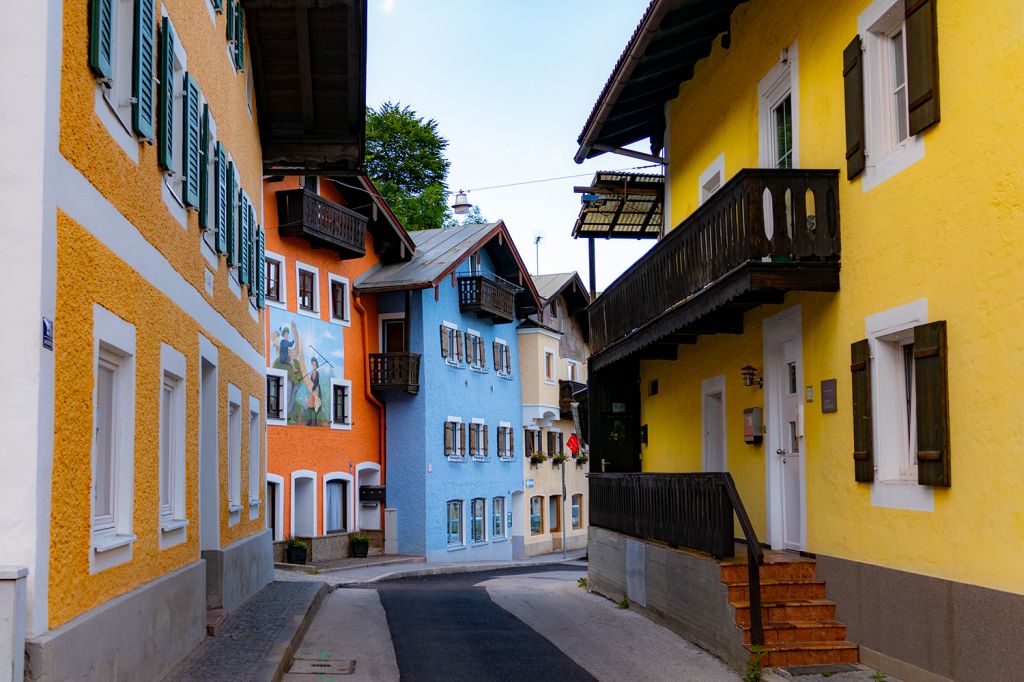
[575,0,744,163]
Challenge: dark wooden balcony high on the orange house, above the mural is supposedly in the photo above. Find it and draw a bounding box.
[278,189,367,259]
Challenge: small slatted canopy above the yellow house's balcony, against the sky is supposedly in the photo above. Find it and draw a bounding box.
[572,171,665,240]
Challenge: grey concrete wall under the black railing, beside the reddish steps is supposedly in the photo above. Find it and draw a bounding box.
[588,526,750,667]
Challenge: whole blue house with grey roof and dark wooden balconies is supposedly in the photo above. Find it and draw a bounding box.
[354,222,539,561]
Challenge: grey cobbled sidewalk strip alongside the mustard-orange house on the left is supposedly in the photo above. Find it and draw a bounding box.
[164,581,328,682]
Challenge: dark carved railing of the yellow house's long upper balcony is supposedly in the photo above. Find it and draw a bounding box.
[589,169,840,355]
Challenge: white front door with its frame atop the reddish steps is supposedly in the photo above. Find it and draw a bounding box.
[765,308,807,550]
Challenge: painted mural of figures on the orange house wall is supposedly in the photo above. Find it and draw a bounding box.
[267,307,344,427]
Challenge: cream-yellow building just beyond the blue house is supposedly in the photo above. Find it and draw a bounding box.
[513,272,590,558]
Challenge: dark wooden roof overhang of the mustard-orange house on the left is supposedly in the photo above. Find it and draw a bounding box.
[241,0,367,175]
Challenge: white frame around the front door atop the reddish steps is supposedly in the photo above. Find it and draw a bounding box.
[762,304,807,550]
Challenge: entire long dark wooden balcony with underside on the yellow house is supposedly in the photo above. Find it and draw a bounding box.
[588,169,840,371]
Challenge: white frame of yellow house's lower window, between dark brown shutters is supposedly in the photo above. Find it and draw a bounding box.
[864,298,935,511]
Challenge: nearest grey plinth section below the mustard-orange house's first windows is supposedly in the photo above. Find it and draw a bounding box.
[25,561,206,682]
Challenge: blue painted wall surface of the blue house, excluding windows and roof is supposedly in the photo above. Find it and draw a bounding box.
[379,244,523,561]
